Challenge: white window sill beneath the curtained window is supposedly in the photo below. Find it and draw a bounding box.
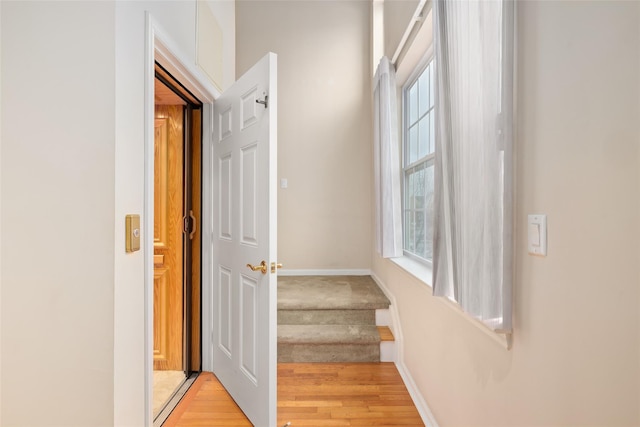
[390,256,512,350]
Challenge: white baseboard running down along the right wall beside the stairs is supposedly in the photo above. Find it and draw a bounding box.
[370,272,438,427]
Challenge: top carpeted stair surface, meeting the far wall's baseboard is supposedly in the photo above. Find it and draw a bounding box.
[278,276,390,310]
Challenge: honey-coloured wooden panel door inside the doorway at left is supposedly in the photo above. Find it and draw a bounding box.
[153,105,184,371]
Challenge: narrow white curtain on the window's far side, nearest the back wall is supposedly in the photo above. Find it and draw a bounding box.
[373,56,402,258]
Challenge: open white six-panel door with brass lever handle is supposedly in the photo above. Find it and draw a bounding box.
[212,53,277,427]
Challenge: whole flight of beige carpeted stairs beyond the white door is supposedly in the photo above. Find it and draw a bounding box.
[278,276,389,362]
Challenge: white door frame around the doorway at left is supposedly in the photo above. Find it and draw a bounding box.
[142,12,220,427]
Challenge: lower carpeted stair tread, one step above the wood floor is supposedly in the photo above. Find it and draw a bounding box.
[278,325,380,344]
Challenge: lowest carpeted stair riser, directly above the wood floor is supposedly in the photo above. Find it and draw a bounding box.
[278,344,380,363]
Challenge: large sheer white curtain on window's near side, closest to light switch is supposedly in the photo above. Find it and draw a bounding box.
[433,0,514,332]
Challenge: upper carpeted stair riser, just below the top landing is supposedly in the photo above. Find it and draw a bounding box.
[278,310,376,325]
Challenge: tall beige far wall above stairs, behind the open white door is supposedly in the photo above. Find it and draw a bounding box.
[236,0,373,269]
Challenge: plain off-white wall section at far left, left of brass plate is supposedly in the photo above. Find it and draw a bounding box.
[0,1,115,427]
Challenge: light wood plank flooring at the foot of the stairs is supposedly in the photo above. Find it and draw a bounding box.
[163,363,424,427]
